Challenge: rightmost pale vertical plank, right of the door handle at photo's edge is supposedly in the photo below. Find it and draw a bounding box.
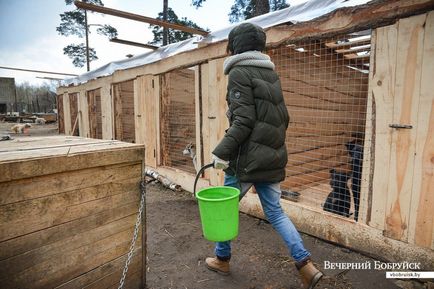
[409,12,434,250]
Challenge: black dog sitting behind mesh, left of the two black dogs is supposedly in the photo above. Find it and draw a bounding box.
[323,169,351,217]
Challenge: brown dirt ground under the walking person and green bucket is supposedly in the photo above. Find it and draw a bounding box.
[146,184,427,289]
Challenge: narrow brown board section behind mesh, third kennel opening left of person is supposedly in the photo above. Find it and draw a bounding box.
[87,89,103,139]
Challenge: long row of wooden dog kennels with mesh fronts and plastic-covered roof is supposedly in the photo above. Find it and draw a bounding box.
[58,0,434,268]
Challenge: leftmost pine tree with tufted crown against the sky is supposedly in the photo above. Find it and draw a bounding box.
[56,0,118,70]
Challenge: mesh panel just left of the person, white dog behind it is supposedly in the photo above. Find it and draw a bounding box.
[161,68,196,174]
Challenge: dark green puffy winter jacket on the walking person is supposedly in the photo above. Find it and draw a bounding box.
[213,51,289,182]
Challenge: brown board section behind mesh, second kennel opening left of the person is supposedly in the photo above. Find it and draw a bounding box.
[112,80,135,142]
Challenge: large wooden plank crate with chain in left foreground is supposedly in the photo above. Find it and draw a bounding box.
[0,136,146,288]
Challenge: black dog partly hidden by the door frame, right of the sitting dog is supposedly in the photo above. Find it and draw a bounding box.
[345,141,363,221]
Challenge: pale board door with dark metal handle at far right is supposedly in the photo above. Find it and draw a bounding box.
[370,12,434,248]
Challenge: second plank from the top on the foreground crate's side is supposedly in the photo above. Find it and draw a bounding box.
[0,163,141,205]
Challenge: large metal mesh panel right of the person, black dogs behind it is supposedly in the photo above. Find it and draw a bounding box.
[268,35,370,219]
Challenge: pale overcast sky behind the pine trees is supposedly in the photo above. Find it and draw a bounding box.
[0,0,306,84]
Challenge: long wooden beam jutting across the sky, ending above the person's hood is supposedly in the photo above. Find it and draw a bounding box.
[74,1,209,36]
